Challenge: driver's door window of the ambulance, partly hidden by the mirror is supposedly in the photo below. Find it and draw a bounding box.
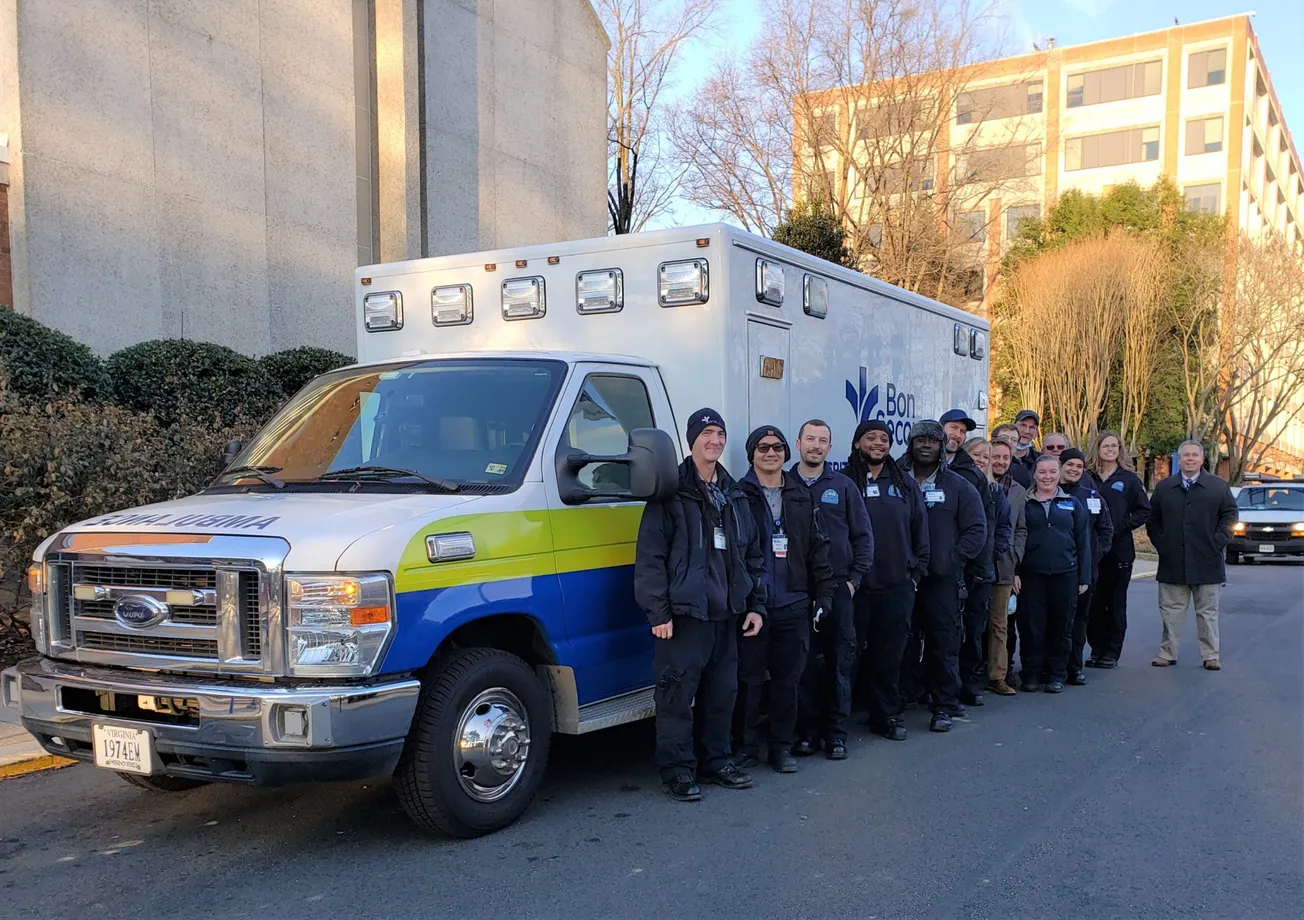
[566,374,655,491]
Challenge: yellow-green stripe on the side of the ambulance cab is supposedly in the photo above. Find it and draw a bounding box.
[395,504,643,592]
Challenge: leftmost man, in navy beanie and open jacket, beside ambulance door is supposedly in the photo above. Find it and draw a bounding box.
[634,409,765,801]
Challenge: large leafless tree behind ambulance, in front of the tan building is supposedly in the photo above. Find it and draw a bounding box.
[673,0,1042,302]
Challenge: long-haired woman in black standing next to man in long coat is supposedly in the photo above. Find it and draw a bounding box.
[1086,431,1150,667]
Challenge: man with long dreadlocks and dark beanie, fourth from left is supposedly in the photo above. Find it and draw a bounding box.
[845,418,928,741]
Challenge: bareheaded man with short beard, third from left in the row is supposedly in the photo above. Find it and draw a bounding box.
[793,418,874,760]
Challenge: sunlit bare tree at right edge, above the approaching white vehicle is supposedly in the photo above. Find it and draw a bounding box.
[1213,232,1304,482]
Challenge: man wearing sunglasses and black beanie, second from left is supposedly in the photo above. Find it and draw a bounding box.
[735,425,835,773]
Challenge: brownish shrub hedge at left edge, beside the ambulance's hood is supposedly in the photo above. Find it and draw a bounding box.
[0,365,257,582]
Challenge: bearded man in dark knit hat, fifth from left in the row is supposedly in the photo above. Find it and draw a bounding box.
[901,418,987,731]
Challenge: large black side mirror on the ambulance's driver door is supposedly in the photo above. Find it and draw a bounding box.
[557,427,679,504]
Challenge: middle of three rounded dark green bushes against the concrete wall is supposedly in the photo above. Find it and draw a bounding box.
[104,339,282,426]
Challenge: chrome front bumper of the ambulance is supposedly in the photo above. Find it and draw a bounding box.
[0,658,421,786]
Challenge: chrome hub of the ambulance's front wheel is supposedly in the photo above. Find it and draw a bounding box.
[452,687,529,801]
